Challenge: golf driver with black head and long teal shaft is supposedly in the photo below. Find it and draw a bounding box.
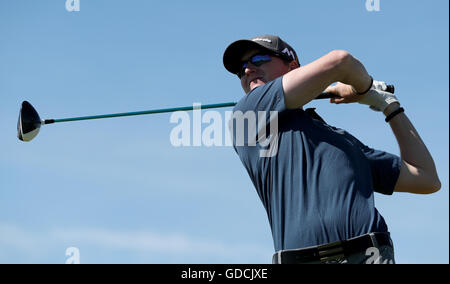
[17,85,395,142]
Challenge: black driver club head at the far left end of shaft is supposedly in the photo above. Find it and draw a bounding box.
[17,101,42,142]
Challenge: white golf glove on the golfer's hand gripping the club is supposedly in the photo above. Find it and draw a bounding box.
[359,80,400,112]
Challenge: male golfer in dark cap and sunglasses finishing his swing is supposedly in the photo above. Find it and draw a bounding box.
[223,35,441,263]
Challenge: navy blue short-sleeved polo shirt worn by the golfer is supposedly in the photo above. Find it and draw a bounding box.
[232,77,401,251]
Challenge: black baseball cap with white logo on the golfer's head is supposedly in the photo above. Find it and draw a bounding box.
[223,35,300,74]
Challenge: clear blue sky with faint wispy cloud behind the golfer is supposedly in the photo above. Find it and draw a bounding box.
[0,0,449,263]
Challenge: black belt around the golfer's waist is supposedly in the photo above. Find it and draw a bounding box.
[272,233,393,264]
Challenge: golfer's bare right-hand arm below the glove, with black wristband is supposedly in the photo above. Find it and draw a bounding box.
[384,103,441,194]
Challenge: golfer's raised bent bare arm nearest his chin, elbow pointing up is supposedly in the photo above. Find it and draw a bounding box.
[283,50,371,109]
